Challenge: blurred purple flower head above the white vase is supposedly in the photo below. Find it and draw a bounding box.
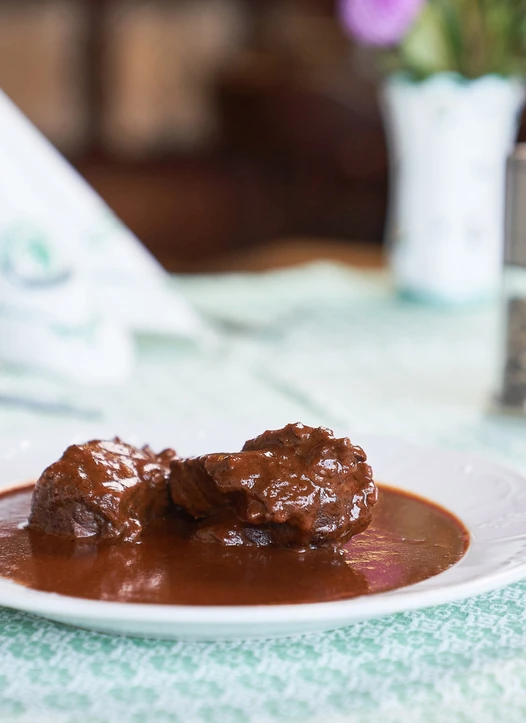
[340,0,426,46]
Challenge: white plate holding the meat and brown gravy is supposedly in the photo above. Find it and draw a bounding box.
[0,427,526,640]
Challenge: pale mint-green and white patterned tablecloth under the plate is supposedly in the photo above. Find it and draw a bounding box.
[0,265,526,723]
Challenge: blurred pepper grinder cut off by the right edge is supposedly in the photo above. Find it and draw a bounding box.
[497,143,526,416]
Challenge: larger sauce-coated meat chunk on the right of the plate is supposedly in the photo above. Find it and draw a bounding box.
[170,424,377,547]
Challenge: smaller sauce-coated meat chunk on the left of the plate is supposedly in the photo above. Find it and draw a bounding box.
[29,437,176,540]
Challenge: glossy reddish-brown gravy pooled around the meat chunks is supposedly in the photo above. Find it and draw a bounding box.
[0,485,469,605]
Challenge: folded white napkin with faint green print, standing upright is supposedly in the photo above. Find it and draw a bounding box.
[0,91,200,383]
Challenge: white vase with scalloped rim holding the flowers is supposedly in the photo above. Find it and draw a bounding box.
[382,73,525,304]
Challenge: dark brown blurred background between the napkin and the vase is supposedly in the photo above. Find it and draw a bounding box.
[0,0,404,271]
